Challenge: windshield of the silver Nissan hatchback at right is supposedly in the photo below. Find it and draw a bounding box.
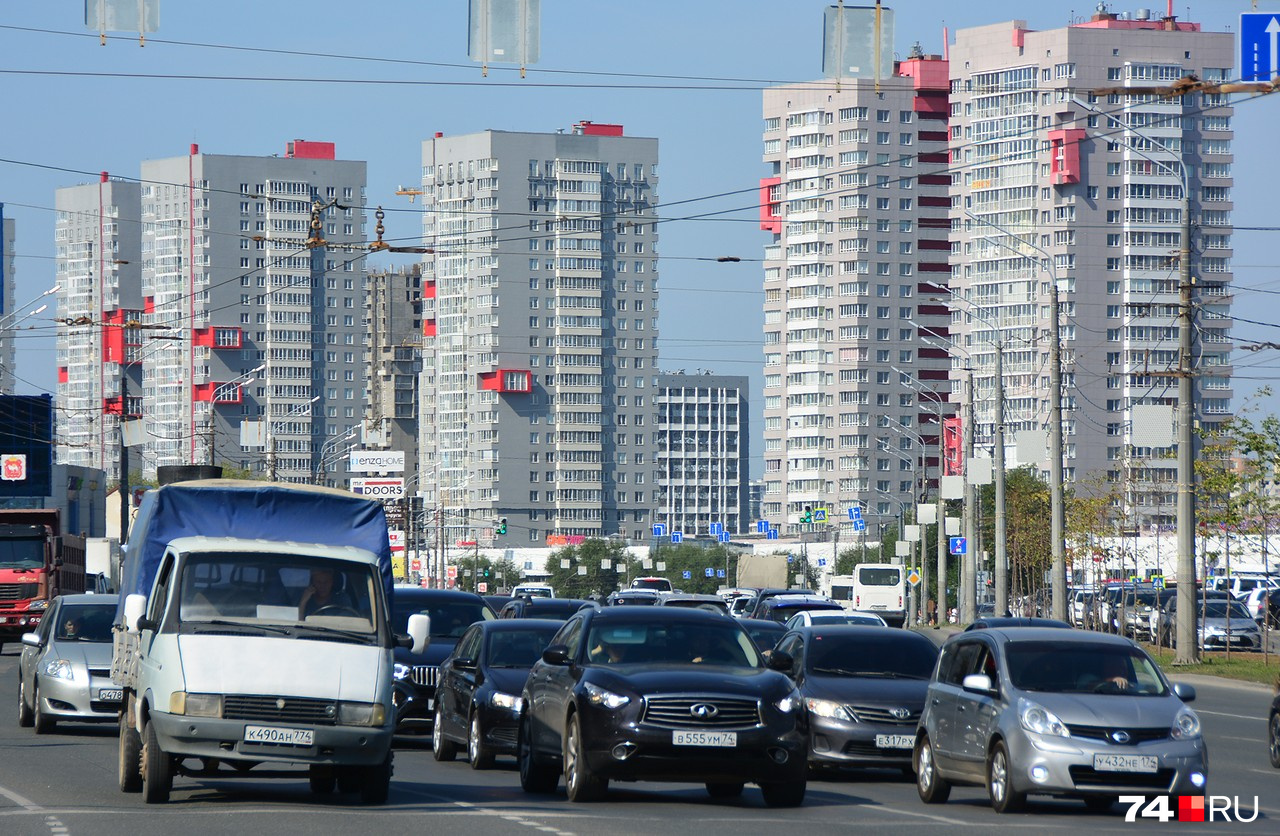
[1005,641,1167,696]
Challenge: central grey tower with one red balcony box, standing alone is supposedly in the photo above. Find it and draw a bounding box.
[420,122,658,545]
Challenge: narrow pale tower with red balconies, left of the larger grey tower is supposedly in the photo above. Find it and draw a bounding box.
[54,172,145,481]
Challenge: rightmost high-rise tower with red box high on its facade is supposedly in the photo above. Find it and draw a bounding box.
[951,12,1235,525]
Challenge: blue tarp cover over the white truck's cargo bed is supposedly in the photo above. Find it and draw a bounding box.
[116,479,394,620]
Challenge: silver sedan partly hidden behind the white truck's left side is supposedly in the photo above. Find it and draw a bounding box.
[18,595,120,735]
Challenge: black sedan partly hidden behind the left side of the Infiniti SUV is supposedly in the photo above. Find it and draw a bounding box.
[431,618,564,769]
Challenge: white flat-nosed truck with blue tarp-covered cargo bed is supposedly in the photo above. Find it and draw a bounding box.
[111,480,429,804]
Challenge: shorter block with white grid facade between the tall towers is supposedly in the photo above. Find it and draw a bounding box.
[653,373,751,538]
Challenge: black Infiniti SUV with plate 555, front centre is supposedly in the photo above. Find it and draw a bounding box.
[517,607,808,807]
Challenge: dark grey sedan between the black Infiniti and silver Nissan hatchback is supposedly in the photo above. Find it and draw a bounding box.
[774,625,938,771]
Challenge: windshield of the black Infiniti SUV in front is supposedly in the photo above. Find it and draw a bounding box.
[586,618,760,667]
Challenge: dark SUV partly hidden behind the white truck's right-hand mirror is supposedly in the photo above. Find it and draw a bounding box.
[392,586,497,731]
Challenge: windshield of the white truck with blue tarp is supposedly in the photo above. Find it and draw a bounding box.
[178,553,379,634]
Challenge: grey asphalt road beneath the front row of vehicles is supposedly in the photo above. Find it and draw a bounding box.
[0,648,1280,836]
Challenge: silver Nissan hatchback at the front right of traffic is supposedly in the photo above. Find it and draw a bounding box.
[913,627,1208,813]
